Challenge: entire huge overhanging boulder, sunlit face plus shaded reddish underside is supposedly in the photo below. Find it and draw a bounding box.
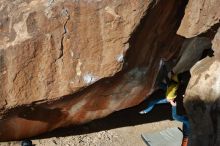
[0,0,186,141]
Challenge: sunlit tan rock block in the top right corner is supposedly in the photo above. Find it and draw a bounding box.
[177,0,220,38]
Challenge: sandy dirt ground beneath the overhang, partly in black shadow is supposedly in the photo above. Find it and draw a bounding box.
[0,93,181,146]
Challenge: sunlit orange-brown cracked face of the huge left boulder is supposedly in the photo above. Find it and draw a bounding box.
[0,0,149,108]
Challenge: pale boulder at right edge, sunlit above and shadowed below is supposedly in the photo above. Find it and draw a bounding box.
[184,28,220,146]
